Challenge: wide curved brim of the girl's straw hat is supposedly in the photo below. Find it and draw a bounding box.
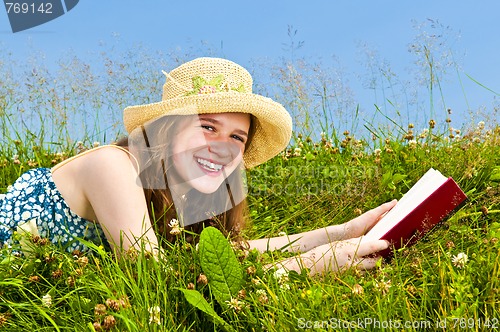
[123,91,292,168]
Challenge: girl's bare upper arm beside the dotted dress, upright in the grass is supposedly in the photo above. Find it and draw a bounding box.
[80,148,158,252]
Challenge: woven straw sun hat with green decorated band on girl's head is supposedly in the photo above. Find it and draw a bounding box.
[123,58,292,168]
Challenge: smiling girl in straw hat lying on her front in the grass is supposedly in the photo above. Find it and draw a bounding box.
[0,58,394,274]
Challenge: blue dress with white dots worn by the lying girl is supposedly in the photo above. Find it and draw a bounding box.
[0,168,109,252]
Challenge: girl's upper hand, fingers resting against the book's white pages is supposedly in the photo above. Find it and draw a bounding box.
[337,200,397,240]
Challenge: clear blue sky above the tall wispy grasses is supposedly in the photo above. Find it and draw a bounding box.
[0,0,500,131]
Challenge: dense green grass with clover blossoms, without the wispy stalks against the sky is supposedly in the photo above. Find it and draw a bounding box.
[0,116,500,331]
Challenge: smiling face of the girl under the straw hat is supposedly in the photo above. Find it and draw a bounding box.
[172,113,250,194]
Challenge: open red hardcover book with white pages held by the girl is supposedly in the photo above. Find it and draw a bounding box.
[363,168,467,257]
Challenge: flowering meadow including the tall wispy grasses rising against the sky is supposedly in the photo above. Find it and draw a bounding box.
[0,36,500,331]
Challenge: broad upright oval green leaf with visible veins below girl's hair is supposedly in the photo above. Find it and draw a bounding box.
[199,227,243,307]
